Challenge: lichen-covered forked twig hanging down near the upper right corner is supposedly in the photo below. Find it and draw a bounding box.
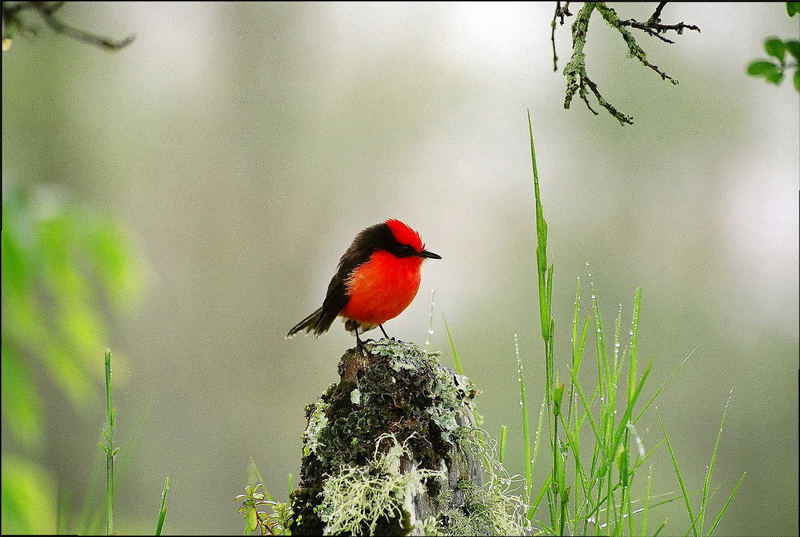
[550,2,700,125]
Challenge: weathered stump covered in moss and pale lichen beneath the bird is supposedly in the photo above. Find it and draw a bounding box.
[291,339,522,535]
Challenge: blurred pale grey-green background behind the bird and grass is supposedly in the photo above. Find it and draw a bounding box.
[2,2,800,535]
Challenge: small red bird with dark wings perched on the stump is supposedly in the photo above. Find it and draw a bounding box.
[287,220,441,347]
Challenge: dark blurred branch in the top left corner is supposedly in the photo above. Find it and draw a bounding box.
[2,2,135,51]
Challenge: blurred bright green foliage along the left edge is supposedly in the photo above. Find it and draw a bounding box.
[2,186,144,533]
